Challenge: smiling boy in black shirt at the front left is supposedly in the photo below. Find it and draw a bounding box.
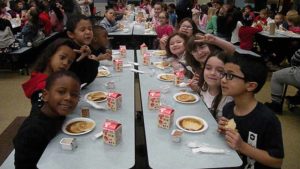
[13,71,80,169]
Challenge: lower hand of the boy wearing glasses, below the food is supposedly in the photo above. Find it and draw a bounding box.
[225,129,244,151]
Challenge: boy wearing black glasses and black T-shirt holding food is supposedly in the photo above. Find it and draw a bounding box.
[218,53,284,169]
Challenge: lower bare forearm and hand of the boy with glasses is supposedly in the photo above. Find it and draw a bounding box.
[225,129,282,168]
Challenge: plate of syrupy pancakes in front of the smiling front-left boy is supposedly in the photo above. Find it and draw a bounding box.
[62,117,96,135]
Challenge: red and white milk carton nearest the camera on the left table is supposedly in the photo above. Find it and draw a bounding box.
[103,119,122,146]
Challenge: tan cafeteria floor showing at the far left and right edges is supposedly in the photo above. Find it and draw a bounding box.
[0,71,300,169]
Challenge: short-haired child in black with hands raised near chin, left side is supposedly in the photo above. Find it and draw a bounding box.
[67,15,99,84]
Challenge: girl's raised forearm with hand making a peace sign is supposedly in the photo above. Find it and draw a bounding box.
[195,34,235,55]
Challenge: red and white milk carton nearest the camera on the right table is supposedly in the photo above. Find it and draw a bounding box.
[158,106,174,129]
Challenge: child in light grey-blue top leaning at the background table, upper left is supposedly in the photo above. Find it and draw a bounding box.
[99,8,122,32]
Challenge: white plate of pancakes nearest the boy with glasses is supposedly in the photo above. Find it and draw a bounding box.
[176,116,208,133]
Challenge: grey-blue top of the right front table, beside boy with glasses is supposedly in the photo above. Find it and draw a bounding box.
[137,51,242,169]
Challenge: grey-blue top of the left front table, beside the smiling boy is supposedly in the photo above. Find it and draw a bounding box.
[38,50,135,169]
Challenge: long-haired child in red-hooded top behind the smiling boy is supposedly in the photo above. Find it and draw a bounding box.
[22,39,76,112]
